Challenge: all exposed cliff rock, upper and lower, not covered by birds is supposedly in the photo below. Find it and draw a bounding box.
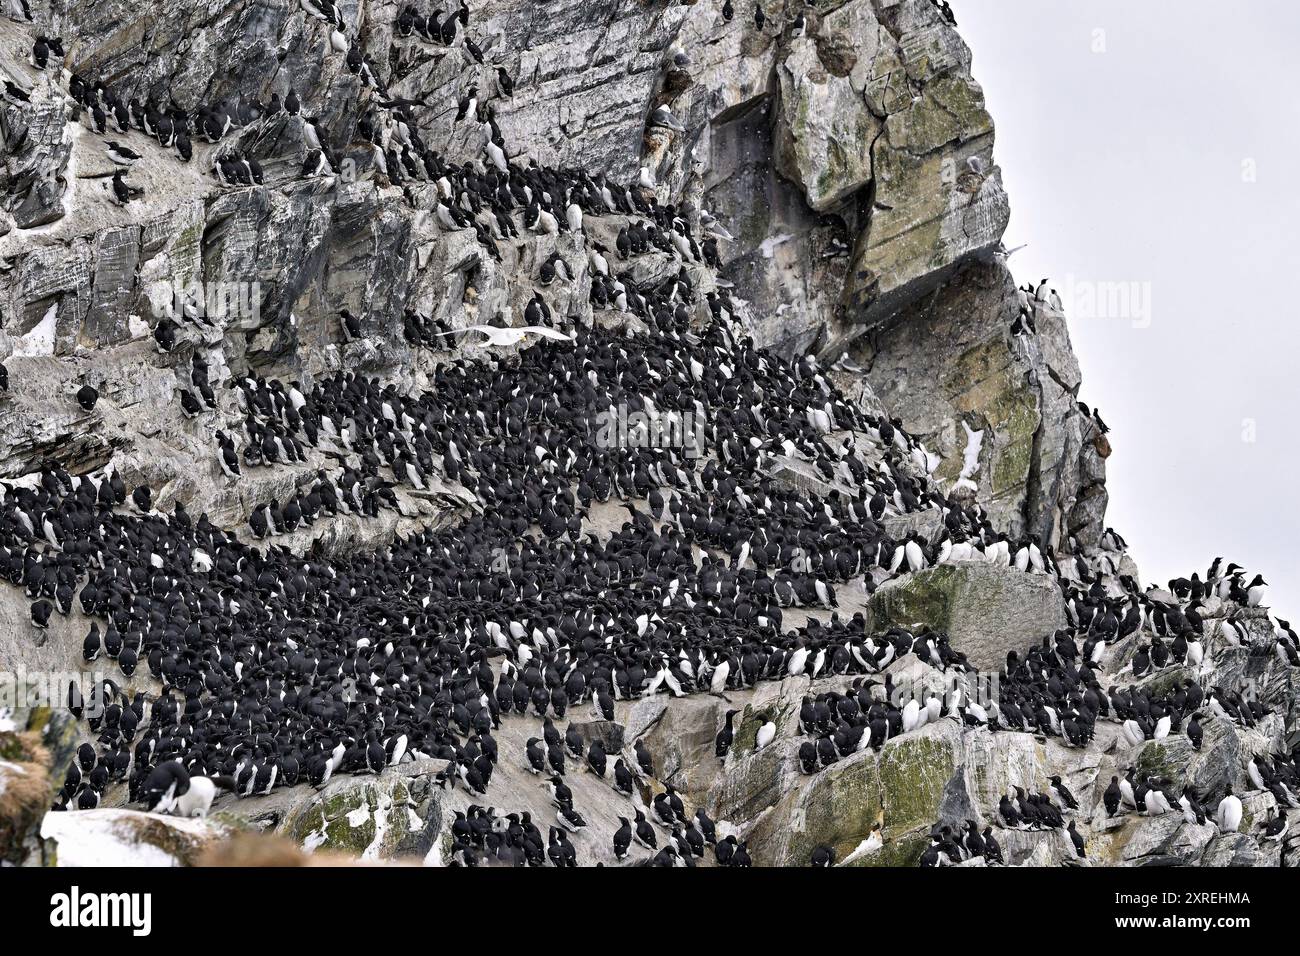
[0,0,1291,865]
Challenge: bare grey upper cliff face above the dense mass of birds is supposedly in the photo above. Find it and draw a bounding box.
[0,0,1086,545]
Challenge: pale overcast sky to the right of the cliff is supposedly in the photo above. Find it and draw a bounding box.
[952,0,1300,619]
